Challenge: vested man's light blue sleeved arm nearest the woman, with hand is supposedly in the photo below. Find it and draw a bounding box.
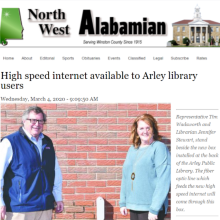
[53,157,63,212]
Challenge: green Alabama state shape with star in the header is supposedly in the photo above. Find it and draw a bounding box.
[0,8,23,45]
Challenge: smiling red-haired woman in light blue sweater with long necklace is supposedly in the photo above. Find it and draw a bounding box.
[119,114,171,220]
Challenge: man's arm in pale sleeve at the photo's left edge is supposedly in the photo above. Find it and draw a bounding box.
[0,138,13,219]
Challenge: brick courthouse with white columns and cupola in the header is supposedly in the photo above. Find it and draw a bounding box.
[172,5,220,46]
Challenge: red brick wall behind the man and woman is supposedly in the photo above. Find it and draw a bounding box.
[1,103,171,219]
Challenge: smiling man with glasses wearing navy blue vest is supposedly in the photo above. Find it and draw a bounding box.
[0,106,63,220]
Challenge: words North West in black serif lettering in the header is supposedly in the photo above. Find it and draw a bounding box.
[28,9,70,35]
